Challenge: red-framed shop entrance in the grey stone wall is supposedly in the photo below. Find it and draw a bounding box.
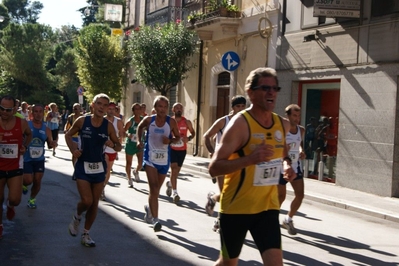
[300,81,340,182]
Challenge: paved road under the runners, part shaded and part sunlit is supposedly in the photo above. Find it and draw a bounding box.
[0,136,399,266]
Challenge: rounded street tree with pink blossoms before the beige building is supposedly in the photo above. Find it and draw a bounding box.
[128,23,196,95]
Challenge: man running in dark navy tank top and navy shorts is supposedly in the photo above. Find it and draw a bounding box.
[65,93,122,247]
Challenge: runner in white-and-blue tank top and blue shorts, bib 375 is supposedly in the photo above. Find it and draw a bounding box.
[137,96,180,232]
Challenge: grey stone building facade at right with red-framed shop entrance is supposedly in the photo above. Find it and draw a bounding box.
[276,0,399,197]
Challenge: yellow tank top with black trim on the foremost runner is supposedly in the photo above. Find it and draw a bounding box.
[220,110,285,214]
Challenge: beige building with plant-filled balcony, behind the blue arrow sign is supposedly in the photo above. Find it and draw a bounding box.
[123,0,282,157]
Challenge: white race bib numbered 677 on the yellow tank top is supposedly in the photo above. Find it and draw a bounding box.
[253,159,283,186]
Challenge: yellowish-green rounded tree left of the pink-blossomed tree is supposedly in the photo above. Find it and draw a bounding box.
[75,24,127,100]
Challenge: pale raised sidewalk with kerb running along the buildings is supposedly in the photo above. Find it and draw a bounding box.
[182,155,399,223]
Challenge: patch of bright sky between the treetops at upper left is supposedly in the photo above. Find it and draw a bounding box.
[37,0,87,28]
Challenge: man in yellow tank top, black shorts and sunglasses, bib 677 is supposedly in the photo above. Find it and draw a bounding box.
[209,68,295,265]
